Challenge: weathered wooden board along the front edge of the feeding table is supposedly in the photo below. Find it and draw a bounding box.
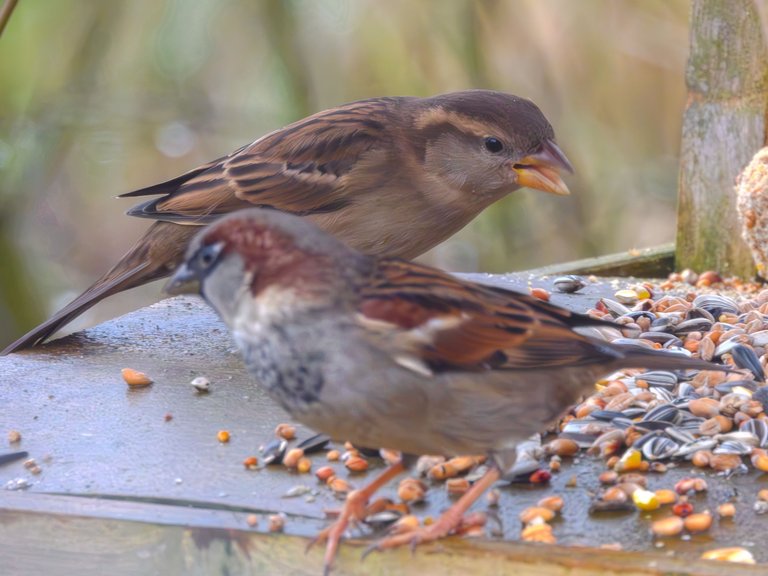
[0,494,765,576]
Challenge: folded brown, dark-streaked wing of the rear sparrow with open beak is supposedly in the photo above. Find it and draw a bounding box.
[123,98,397,224]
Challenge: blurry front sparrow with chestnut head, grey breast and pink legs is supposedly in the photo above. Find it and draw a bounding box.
[166,209,715,569]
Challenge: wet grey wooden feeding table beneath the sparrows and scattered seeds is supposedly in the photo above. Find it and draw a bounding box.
[0,274,768,575]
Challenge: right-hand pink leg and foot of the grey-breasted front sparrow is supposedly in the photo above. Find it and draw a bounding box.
[363,466,500,556]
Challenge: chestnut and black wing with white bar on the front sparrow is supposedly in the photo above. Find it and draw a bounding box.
[359,259,612,371]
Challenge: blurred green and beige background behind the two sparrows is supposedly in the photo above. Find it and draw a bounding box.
[0,0,689,347]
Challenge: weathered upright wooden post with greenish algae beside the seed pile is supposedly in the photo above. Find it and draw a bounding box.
[676,0,768,278]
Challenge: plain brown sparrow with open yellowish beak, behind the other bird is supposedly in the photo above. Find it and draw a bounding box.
[0,90,572,354]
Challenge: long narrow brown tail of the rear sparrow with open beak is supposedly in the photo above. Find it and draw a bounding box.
[0,222,199,356]
